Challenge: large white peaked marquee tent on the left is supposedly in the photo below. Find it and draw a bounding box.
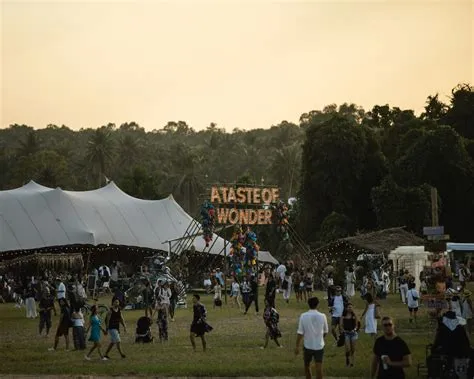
[0,181,276,263]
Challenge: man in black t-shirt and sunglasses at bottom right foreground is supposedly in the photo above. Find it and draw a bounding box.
[370,317,412,379]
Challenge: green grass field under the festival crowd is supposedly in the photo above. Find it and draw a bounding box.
[0,293,434,378]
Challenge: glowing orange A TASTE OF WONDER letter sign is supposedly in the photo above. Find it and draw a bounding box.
[210,186,280,225]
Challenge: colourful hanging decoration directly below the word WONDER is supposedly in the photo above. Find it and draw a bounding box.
[230,225,260,278]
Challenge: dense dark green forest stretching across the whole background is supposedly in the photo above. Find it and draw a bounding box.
[0,84,474,254]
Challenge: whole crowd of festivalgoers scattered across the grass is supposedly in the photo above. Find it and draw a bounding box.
[2,262,473,379]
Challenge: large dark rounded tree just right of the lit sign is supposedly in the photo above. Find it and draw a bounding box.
[299,115,368,240]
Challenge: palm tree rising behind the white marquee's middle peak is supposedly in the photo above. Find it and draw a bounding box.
[86,127,115,187]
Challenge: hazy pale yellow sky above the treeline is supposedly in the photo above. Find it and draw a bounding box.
[0,0,474,130]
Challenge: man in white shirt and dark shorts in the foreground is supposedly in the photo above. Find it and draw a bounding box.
[295,297,329,379]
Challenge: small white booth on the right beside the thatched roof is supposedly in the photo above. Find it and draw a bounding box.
[388,246,430,288]
